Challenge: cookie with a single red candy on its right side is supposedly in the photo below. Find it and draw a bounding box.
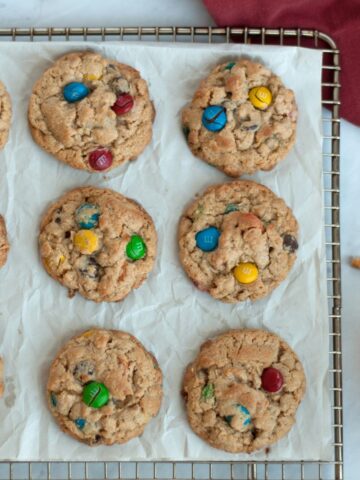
[183,330,306,453]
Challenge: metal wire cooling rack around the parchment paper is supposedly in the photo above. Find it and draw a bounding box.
[0,27,343,480]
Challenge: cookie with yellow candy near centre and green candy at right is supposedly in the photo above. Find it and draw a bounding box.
[39,187,157,302]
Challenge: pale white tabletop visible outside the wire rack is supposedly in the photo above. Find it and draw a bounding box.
[0,0,360,480]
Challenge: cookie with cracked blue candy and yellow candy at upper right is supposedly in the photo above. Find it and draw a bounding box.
[182,59,297,177]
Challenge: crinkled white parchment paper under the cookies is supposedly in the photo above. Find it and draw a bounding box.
[0,42,331,461]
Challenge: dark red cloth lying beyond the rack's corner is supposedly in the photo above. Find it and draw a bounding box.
[203,0,360,125]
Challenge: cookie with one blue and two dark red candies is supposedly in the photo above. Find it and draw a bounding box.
[28,51,155,172]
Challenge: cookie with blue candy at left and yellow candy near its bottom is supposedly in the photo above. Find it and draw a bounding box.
[178,180,298,303]
